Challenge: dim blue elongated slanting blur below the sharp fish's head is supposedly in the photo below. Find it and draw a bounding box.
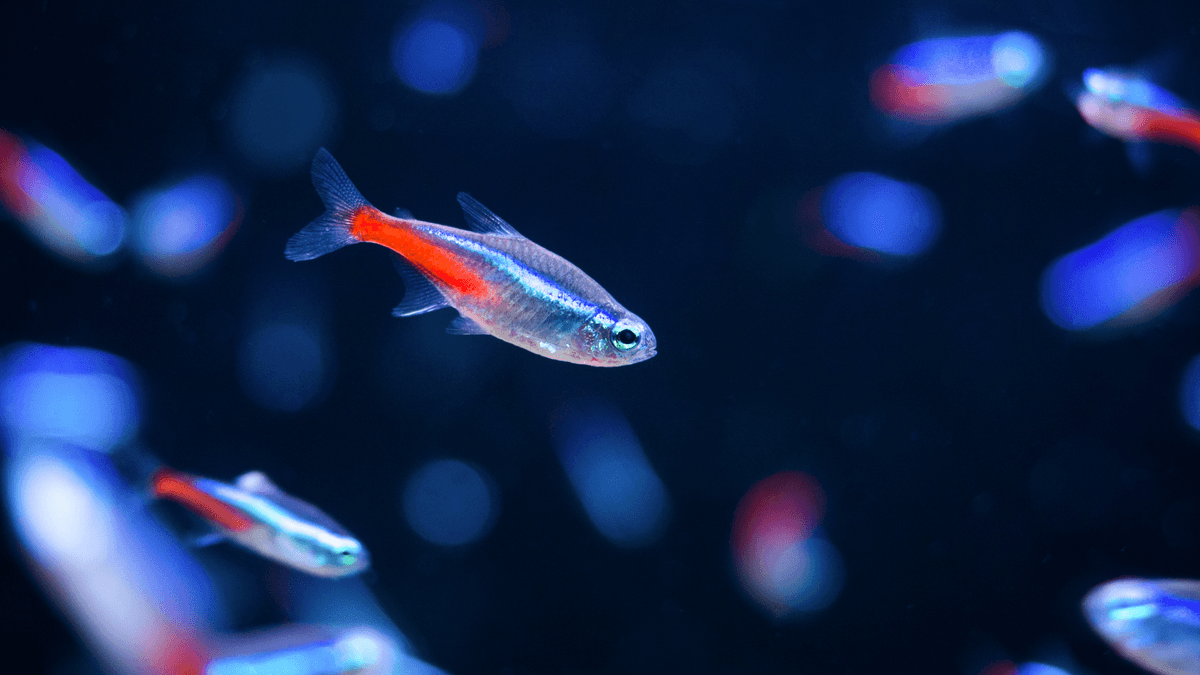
[556,405,668,546]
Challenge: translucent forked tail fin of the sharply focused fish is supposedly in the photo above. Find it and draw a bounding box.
[283,148,371,261]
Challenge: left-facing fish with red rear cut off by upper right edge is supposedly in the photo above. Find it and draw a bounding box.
[1075,68,1200,153]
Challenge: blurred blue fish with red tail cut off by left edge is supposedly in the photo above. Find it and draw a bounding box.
[0,129,126,264]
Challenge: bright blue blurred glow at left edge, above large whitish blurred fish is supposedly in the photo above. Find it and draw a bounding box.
[0,345,139,452]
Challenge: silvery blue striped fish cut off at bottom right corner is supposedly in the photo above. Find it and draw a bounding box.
[1082,579,1200,675]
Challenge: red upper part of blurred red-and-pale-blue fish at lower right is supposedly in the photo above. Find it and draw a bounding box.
[730,471,826,558]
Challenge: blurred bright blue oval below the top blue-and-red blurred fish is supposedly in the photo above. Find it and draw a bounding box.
[821,173,941,256]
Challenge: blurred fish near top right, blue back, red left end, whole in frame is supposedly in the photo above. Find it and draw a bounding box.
[870,31,1046,124]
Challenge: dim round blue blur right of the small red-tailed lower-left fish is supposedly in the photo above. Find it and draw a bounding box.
[403,460,496,546]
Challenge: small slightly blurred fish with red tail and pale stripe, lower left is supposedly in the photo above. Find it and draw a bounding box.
[150,467,370,577]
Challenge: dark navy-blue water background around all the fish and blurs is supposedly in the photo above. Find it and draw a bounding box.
[0,0,1200,675]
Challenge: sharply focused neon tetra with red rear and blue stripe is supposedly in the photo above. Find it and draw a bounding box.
[284,148,658,366]
